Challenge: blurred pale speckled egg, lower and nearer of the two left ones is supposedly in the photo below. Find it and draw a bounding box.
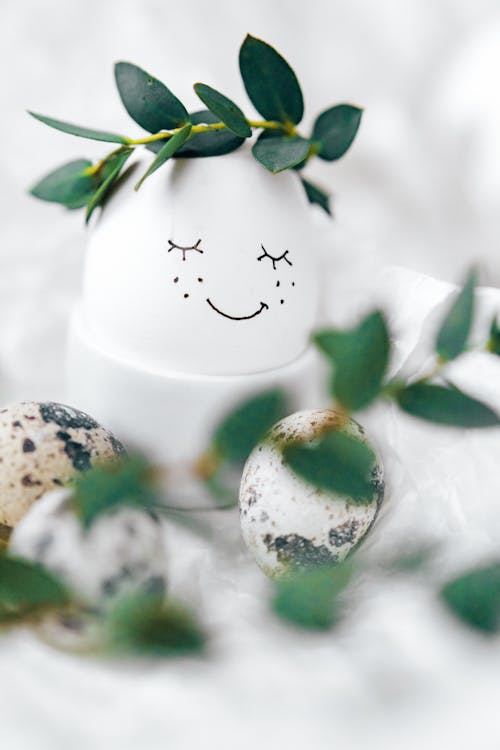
[9,489,167,648]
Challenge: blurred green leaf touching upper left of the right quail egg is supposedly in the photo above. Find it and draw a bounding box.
[213,390,287,468]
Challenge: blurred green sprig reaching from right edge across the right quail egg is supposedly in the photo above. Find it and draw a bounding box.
[192,270,500,507]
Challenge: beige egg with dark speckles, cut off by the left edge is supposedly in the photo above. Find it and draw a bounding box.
[0,401,125,532]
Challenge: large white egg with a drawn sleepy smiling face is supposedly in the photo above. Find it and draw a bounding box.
[82,146,318,375]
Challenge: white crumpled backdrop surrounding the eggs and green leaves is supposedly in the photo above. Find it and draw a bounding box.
[0,0,500,750]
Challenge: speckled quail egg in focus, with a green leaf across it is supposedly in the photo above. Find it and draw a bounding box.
[239,409,384,577]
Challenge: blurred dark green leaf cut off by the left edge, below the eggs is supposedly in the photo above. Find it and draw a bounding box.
[0,554,70,622]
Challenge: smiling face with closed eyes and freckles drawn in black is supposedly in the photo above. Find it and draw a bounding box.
[168,238,295,322]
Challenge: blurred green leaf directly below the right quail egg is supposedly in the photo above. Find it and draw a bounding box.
[272,561,353,630]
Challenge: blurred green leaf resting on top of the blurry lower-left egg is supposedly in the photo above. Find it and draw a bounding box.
[73,455,160,528]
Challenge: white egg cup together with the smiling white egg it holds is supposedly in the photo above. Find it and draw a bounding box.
[66,146,321,463]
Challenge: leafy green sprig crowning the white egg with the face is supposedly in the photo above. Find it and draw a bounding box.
[29,35,362,221]
